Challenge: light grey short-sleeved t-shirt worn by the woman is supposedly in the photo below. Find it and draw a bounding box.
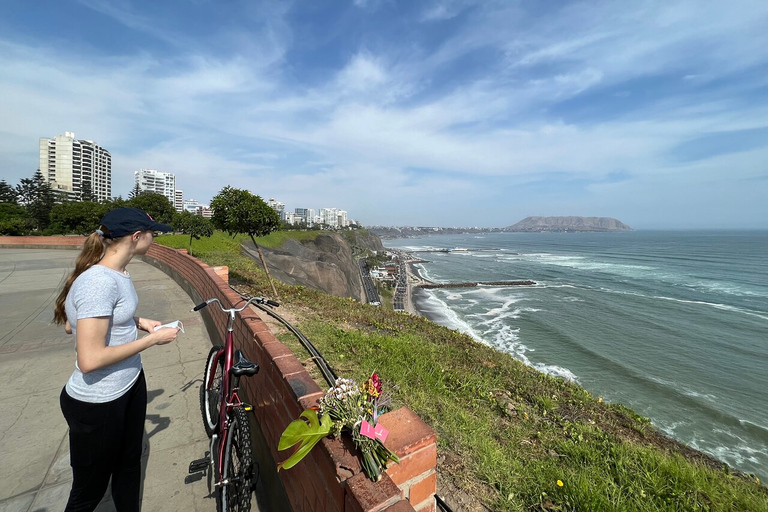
[65,265,141,402]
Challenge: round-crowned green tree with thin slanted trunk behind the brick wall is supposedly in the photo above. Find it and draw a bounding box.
[211,186,280,298]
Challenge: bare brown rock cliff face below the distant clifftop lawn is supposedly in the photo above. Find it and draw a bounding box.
[243,231,385,302]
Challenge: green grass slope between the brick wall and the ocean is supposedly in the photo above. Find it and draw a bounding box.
[158,237,768,512]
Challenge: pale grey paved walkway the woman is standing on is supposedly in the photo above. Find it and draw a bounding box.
[0,248,228,512]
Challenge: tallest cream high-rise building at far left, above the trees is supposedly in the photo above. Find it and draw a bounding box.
[40,132,112,201]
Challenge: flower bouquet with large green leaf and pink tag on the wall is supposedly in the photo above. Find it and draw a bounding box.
[277,373,399,481]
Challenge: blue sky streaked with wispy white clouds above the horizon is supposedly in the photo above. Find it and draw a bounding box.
[0,0,768,229]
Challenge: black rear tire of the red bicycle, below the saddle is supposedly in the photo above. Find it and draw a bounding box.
[219,407,253,512]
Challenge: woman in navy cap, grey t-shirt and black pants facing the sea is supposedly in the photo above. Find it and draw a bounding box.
[54,208,178,512]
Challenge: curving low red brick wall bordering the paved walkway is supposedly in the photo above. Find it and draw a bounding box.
[0,237,437,512]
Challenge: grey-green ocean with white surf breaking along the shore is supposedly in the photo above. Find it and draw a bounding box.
[384,231,768,481]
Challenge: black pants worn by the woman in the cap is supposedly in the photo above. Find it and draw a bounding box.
[60,370,147,512]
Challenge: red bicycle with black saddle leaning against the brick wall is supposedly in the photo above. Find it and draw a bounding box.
[189,297,280,512]
